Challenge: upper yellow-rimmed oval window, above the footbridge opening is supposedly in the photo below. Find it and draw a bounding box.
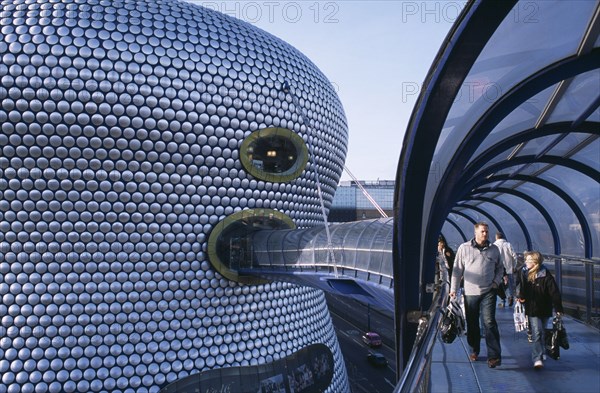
[240,127,308,183]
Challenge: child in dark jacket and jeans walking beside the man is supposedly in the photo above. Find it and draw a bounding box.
[516,251,563,370]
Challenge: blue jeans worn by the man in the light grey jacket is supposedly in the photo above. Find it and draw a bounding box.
[465,289,502,359]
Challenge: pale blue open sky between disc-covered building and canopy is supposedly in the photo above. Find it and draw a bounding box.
[191,0,465,180]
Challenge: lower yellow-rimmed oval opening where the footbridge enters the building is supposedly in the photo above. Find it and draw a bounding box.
[208,209,296,284]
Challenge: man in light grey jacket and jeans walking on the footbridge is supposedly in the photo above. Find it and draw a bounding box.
[450,222,504,368]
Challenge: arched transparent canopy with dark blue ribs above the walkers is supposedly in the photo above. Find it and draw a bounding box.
[393,0,600,376]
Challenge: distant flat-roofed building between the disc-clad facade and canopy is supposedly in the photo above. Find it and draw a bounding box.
[329,180,395,222]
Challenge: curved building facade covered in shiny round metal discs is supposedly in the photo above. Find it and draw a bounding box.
[0,0,348,392]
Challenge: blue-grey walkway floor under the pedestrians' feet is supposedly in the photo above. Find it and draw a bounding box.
[431,307,600,393]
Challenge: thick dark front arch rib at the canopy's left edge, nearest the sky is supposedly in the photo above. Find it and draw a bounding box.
[393,0,517,375]
